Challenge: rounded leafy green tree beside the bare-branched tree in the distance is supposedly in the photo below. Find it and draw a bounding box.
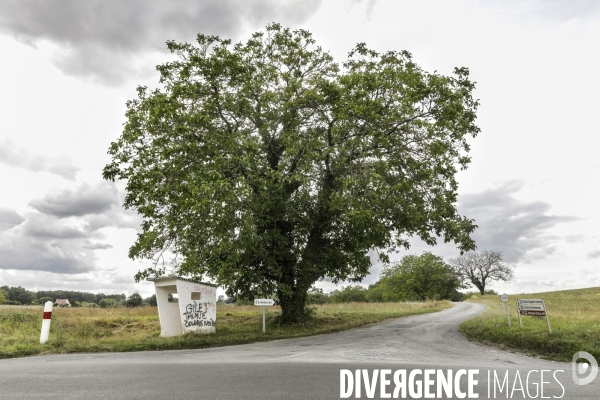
[379,252,461,301]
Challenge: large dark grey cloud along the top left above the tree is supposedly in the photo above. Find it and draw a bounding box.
[0,0,321,85]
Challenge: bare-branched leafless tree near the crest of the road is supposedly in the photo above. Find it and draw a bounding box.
[450,251,514,296]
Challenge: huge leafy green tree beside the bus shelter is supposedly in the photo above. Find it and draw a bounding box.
[103,24,479,323]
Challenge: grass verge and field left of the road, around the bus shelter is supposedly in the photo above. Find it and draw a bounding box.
[0,301,451,358]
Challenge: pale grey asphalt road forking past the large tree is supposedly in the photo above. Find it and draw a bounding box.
[0,303,600,400]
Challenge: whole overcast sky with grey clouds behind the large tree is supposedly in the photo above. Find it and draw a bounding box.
[0,0,600,297]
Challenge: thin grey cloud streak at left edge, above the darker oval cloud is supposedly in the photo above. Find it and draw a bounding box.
[0,139,79,181]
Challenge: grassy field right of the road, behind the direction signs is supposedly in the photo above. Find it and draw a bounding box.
[460,288,600,361]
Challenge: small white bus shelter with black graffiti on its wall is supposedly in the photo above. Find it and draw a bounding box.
[148,277,217,337]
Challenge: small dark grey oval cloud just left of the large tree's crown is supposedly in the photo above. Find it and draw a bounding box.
[29,182,119,218]
